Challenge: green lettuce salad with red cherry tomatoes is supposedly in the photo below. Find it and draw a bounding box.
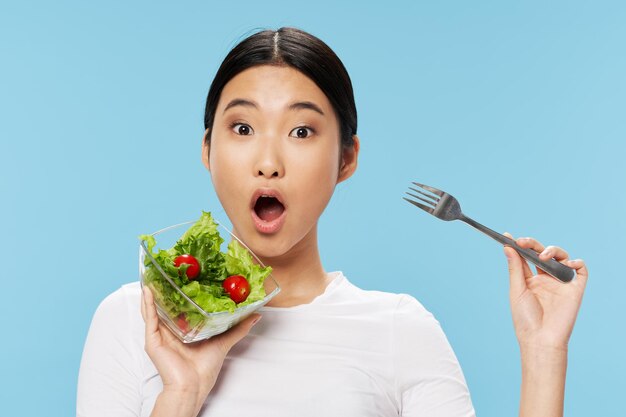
[139,211,272,331]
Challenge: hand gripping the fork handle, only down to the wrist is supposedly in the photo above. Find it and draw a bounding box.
[504,234,588,351]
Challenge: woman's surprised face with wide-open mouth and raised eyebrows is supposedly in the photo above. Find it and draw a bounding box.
[203,65,358,259]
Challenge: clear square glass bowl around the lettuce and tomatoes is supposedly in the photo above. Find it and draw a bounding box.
[139,221,280,343]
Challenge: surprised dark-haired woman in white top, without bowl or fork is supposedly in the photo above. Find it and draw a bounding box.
[77,28,587,417]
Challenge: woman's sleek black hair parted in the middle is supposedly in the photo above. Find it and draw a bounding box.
[204,27,357,146]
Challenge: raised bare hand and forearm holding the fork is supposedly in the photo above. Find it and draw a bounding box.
[504,235,588,417]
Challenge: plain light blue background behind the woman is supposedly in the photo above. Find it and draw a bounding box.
[0,0,626,416]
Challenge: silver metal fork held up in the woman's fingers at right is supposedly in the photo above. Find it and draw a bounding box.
[402,182,576,282]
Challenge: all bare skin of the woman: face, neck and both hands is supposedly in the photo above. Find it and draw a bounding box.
[142,66,587,417]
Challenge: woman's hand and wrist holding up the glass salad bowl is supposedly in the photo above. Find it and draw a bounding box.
[141,286,261,417]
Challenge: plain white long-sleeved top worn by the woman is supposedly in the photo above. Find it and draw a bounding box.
[77,272,474,417]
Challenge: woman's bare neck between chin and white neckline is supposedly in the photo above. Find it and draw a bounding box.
[262,225,328,307]
